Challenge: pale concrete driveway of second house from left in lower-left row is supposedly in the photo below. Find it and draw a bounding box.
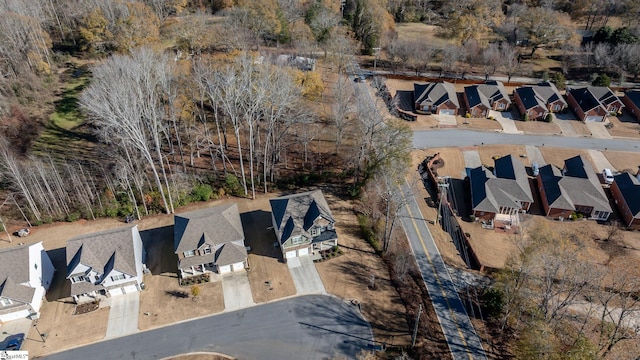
[105,291,140,338]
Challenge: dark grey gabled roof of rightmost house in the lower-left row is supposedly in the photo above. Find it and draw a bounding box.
[269,190,335,244]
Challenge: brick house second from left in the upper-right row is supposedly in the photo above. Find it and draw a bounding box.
[463,81,511,118]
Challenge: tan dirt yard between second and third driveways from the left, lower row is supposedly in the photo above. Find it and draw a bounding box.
[138,274,224,330]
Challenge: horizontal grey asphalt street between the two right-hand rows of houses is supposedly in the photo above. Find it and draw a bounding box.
[413,129,640,152]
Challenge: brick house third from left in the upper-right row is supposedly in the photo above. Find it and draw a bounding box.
[513,82,567,120]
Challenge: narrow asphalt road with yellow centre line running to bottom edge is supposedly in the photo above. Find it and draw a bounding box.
[400,183,487,359]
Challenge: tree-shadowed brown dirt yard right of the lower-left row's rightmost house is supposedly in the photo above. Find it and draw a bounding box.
[316,196,410,346]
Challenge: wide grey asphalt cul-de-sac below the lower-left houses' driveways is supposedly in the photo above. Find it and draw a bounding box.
[44,295,373,360]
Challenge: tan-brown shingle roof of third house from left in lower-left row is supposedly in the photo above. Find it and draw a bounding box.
[173,204,246,255]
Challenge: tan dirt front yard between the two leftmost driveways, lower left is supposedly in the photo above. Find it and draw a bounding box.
[22,299,109,357]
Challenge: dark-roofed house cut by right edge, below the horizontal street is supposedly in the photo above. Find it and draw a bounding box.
[611,171,640,230]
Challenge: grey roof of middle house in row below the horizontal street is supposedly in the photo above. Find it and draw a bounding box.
[539,155,613,212]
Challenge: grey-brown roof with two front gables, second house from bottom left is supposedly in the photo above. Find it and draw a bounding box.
[67,225,138,276]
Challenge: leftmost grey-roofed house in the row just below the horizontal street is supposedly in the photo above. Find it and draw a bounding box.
[469,155,533,220]
